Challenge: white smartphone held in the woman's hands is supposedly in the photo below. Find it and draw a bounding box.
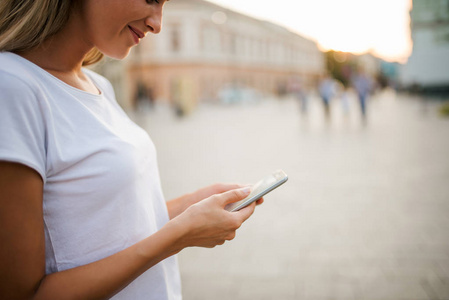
[225,170,288,212]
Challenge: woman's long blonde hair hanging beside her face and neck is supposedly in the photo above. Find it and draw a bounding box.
[0,0,103,66]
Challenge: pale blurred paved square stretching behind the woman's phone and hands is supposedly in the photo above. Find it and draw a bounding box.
[132,91,449,300]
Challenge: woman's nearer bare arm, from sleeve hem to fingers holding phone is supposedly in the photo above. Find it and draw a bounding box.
[0,162,255,300]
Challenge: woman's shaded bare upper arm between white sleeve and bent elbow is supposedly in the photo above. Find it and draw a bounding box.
[0,162,45,299]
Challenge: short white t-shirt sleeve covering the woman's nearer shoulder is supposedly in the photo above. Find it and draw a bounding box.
[0,72,46,182]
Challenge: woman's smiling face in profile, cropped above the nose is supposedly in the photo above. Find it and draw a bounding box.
[79,0,168,59]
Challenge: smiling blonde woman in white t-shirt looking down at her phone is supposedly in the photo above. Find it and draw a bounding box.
[0,0,263,300]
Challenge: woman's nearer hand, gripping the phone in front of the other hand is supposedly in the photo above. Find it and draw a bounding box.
[172,187,256,248]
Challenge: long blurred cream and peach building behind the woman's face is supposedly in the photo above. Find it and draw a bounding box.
[126,0,325,110]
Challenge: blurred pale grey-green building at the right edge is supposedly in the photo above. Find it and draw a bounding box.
[401,0,449,89]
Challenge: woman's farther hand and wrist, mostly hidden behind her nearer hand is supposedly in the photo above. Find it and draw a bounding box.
[167,183,263,219]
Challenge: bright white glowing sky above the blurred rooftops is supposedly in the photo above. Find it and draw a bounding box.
[208,0,412,63]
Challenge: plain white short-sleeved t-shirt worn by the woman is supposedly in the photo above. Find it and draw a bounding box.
[0,52,182,300]
